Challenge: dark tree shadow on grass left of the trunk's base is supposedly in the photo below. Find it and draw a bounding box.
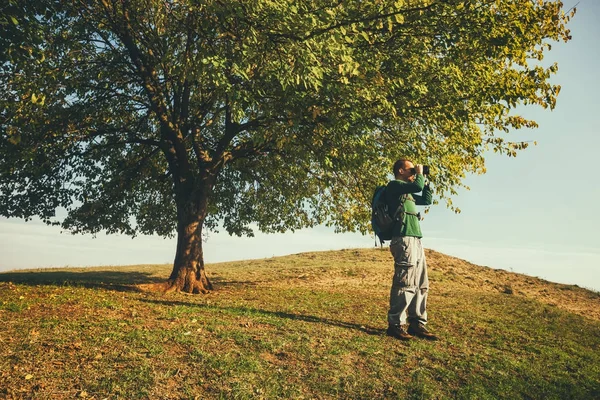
[0,270,165,292]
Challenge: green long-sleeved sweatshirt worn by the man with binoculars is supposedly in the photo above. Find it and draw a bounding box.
[385,174,433,238]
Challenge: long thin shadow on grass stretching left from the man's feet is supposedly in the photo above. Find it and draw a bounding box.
[139,299,385,336]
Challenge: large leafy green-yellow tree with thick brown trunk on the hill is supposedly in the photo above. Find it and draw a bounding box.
[0,0,574,293]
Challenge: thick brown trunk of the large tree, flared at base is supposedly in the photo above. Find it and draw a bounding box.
[167,192,213,294]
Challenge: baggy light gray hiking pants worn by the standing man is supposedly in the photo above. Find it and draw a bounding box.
[388,236,429,325]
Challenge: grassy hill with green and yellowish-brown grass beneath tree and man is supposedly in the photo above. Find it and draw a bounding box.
[0,249,600,399]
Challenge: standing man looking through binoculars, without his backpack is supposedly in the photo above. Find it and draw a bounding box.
[386,159,437,340]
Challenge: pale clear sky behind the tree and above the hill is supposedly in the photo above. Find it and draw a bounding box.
[0,0,600,291]
